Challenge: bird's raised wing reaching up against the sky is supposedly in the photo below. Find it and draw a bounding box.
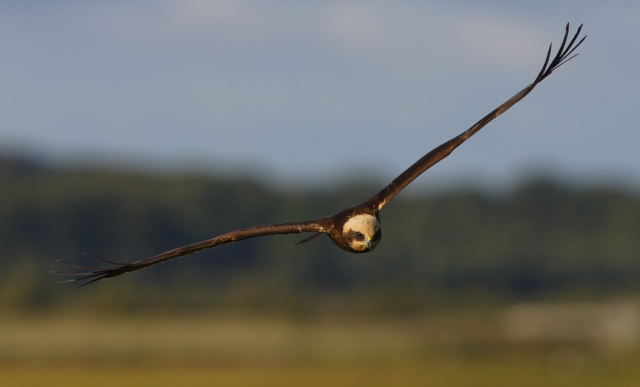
[365,23,586,211]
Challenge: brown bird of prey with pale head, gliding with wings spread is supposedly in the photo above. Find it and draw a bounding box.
[52,23,586,286]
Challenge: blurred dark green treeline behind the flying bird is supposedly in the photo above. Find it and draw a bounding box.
[0,158,640,315]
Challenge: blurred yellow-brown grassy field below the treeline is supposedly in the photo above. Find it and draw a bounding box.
[0,308,640,387]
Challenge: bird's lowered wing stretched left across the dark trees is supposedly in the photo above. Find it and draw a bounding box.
[51,219,326,286]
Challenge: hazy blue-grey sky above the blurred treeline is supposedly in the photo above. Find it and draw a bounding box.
[0,1,640,189]
